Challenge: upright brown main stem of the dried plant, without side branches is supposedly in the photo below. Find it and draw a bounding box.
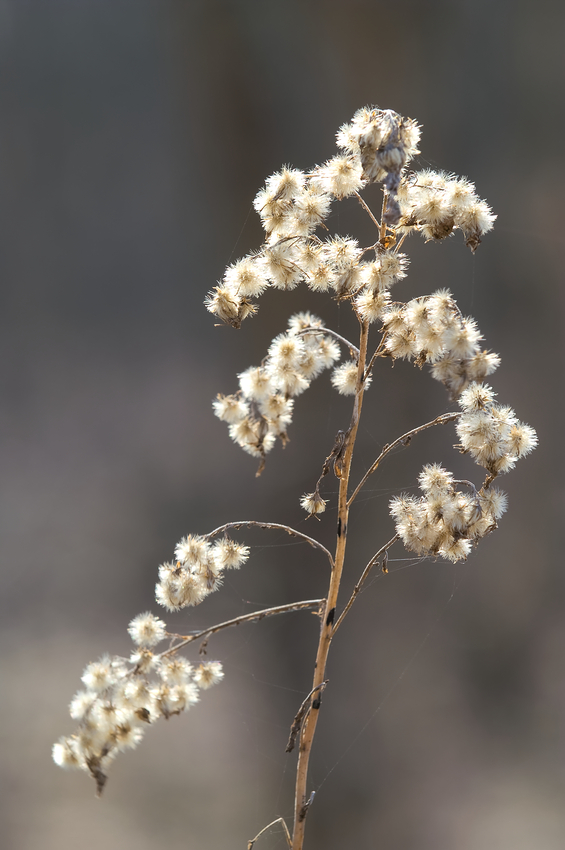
[292,322,369,850]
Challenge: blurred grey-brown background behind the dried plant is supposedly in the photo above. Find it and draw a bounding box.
[0,0,565,850]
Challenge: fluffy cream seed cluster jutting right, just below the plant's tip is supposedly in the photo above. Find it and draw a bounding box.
[398,171,496,252]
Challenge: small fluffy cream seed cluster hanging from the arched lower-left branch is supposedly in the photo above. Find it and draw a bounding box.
[155,534,249,611]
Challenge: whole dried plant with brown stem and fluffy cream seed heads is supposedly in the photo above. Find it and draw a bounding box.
[53,107,537,850]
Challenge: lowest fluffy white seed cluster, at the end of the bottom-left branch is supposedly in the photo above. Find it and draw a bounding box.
[53,613,224,794]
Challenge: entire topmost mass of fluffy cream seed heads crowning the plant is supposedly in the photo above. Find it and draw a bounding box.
[205,107,495,328]
